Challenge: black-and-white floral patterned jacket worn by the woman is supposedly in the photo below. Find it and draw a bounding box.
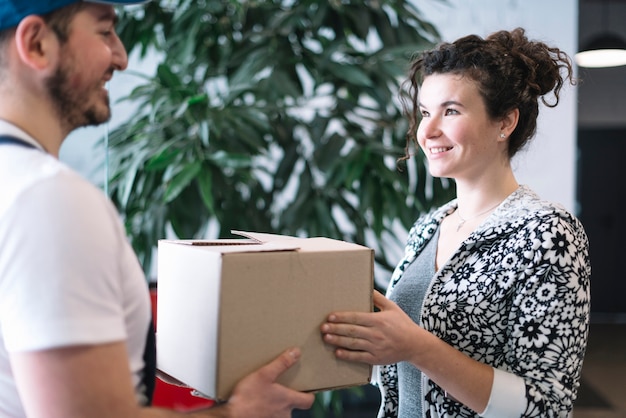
[375,186,591,418]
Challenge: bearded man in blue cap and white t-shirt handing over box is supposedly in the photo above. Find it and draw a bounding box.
[0,0,313,418]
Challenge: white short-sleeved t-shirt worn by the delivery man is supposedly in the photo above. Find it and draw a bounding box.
[0,121,150,417]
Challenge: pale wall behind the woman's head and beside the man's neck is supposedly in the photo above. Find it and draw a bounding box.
[61,0,578,211]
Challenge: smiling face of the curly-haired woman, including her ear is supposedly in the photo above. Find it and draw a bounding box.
[417,74,508,181]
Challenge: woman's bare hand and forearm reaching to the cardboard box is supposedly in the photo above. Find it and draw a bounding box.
[321,291,493,411]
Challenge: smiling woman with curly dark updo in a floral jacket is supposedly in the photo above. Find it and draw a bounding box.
[322,28,591,418]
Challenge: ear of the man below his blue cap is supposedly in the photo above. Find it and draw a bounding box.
[15,15,59,70]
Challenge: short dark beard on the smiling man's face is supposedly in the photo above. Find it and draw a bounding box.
[46,60,111,133]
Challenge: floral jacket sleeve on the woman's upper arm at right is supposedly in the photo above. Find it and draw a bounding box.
[506,213,591,417]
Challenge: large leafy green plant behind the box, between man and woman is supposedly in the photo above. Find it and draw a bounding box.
[109,0,452,280]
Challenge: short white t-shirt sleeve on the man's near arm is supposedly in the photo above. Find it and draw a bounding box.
[0,171,126,351]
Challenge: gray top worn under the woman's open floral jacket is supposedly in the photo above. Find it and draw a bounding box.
[390,229,439,418]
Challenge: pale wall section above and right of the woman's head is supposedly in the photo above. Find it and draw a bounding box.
[414,0,578,211]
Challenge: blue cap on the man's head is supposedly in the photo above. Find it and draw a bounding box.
[0,0,149,30]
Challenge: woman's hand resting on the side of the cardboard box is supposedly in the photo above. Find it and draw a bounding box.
[321,291,420,365]
